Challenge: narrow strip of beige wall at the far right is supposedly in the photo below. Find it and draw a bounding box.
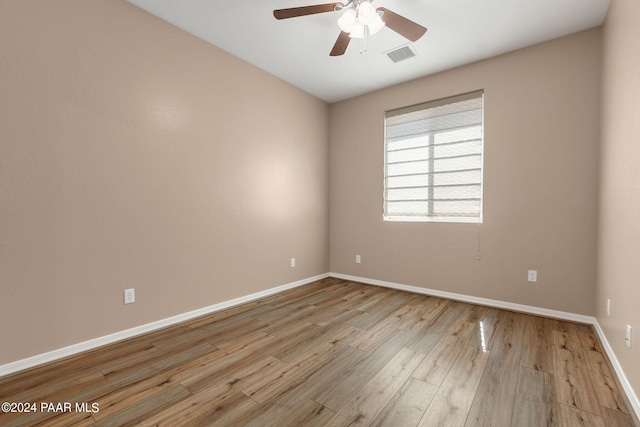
[595,0,640,402]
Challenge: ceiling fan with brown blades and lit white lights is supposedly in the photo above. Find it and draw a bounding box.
[273,0,427,56]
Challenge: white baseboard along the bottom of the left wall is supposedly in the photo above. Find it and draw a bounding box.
[0,273,329,377]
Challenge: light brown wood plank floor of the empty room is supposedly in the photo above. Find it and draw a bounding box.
[0,278,634,427]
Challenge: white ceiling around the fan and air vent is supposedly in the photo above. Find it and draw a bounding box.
[129,0,610,102]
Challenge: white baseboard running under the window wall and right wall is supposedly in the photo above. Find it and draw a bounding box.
[329,273,640,419]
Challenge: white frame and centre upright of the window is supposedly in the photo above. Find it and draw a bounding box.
[382,89,485,224]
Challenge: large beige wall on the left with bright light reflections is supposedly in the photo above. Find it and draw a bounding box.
[0,0,328,364]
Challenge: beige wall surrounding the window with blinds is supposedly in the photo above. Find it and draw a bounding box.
[329,28,601,315]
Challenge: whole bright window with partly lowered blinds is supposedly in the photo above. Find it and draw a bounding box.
[384,91,484,223]
